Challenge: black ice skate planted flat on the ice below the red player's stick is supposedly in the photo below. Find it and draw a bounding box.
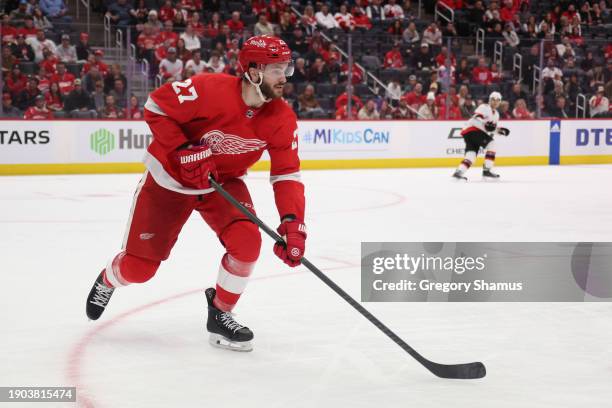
[204,288,253,351]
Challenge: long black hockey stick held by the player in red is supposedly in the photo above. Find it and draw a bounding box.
[210,177,487,379]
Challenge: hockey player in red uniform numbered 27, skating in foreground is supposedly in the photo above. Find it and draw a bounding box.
[86,36,306,351]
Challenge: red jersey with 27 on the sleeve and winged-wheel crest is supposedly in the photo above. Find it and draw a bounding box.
[144,74,304,220]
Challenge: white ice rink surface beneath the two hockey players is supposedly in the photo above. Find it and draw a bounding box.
[0,165,612,408]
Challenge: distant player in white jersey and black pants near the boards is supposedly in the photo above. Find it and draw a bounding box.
[453,92,510,180]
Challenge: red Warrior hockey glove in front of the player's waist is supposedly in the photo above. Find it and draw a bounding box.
[174,144,217,190]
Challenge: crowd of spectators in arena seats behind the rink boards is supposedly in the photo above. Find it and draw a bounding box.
[2,0,612,119]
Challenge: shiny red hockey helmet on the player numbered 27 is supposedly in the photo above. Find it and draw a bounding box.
[238,35,293,76]
